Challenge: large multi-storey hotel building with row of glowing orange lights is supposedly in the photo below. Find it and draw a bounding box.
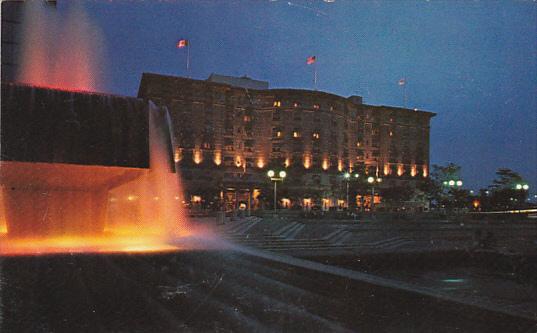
[138,73,435,209]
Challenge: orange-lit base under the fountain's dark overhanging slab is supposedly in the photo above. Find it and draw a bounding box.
[0,161,147,237]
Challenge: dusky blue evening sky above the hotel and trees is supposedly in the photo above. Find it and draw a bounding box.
[58,0,537,192]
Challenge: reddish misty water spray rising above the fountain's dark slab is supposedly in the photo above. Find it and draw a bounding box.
[17,0,103,91]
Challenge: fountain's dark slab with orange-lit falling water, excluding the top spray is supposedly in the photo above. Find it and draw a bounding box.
[0,84,189,254]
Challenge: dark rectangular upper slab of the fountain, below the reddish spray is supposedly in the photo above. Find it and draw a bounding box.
[0,84,149,168]
